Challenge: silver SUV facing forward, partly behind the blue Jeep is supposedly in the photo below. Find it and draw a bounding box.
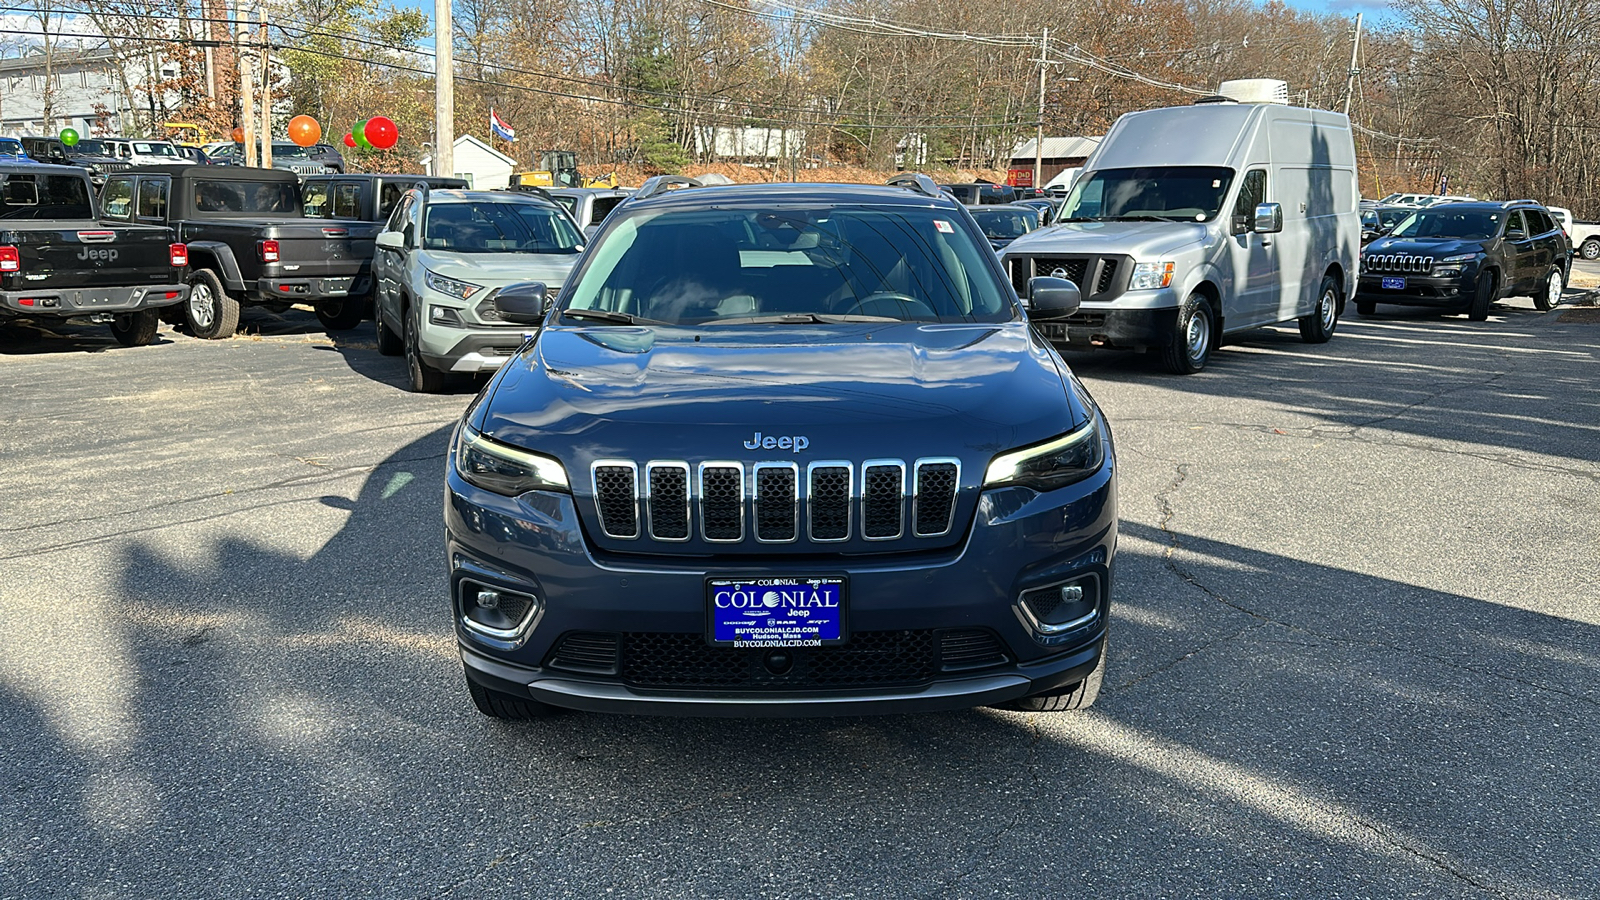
[373,187,584,392]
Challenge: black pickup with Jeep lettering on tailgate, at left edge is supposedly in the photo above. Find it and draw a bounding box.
[0,163,189,346]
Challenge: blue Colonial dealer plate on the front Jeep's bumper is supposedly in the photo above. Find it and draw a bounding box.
[706,577,846,647]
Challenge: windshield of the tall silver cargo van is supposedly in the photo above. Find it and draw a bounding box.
[1061,165,1234,223]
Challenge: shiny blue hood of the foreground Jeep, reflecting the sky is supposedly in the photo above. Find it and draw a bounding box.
[472,323,1086,480]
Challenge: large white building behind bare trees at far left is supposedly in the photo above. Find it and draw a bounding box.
[0,48,179,138]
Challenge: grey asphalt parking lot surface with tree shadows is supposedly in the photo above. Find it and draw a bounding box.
[0,291,1600,898]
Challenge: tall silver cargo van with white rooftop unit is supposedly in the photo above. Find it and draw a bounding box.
[1002,98,1362,375]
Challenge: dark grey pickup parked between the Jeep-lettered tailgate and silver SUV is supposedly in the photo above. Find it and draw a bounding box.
[101,165,381,338]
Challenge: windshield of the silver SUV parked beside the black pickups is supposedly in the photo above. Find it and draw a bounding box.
[422,202,584,253]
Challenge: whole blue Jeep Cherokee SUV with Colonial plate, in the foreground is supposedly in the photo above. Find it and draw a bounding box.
[445,175,1117,719]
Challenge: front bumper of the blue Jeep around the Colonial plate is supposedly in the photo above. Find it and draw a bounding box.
[445,441,1117,716]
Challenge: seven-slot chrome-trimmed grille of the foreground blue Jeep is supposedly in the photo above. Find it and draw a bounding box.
[590,456,962,543]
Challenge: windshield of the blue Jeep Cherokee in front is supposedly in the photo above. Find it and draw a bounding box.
[566,205,1016,325]
